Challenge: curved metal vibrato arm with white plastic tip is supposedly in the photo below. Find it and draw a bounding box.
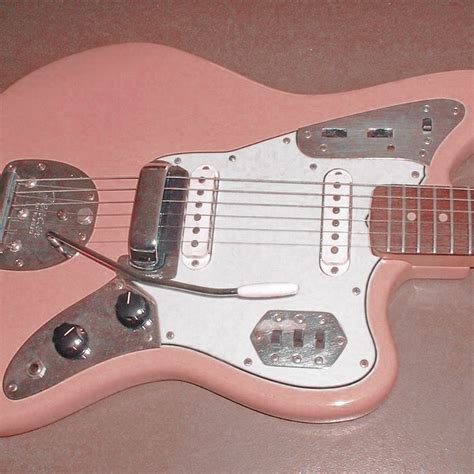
[46,231,298,299]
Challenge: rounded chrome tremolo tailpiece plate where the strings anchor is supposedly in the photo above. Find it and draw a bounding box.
[0,160,98,271]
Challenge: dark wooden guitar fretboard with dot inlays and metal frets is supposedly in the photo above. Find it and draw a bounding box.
[369,185,474,266]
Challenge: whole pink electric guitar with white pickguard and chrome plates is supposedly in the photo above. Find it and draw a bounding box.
[0,44,474,436]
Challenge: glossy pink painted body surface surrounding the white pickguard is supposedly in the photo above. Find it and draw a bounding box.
[0,44,474,436]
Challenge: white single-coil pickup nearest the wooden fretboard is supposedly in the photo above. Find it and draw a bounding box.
[319,169,352,276]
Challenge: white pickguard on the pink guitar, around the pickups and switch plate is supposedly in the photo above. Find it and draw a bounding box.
[142,132,424,388]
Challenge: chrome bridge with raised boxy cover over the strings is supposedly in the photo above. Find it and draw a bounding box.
[129,161,189,278]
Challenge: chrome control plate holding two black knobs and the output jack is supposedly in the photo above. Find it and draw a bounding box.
[3,280,160,400]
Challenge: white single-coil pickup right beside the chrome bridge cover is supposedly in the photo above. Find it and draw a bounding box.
[181,165,219,270]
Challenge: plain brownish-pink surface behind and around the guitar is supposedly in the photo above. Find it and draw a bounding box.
[0,1,474,472]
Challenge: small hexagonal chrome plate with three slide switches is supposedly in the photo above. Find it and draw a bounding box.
[250,311,347,369]
